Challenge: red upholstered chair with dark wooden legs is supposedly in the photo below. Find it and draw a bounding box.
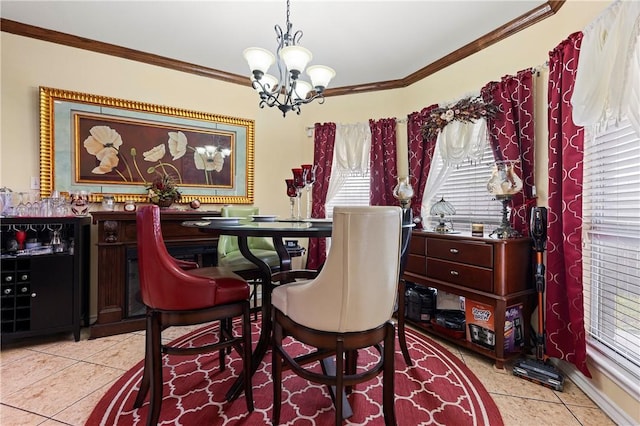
[134,206,253,425]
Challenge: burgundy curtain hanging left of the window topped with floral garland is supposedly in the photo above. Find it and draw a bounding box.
[407,104,438,226]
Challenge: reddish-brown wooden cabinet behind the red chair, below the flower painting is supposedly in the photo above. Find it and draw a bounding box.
[90,209,220,338]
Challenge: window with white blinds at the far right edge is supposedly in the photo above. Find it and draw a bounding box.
[583,120,640,378]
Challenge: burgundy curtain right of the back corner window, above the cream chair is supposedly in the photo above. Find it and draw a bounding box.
[369,118,398,206]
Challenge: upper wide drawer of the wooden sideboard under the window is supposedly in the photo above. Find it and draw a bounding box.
[427,238,493,268]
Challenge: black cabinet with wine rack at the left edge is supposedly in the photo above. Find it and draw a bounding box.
[0,217,90,343]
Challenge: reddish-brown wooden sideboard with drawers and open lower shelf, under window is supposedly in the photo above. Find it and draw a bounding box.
[403,230,535,368]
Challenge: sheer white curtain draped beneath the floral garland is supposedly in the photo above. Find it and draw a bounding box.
[421,118,487,226]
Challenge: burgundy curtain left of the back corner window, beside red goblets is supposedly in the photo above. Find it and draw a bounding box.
[307,123,336,269]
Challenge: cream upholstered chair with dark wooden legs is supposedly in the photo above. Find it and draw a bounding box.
[272,206,402,425]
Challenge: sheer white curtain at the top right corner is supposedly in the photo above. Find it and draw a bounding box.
[571,1,640,135]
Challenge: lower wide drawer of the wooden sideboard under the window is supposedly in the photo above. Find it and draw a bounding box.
[427,257,493,292]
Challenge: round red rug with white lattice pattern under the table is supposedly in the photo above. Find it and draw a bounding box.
[86,321,503,426]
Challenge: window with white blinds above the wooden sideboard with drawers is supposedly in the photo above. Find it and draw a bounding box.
[422,144,502,232]
